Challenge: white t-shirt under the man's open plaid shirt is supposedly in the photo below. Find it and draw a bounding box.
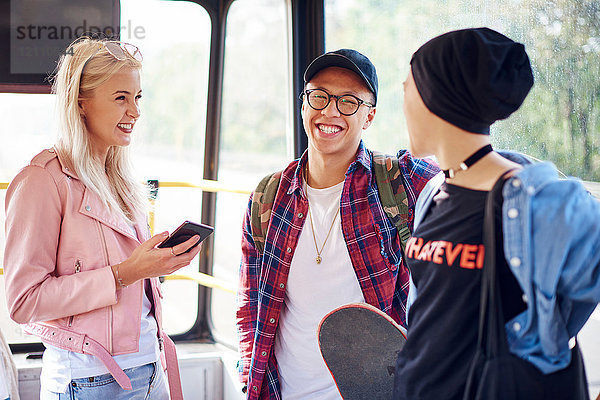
[275,182,364,400]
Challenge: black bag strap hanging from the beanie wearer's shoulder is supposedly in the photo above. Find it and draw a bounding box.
[477,169,513,357]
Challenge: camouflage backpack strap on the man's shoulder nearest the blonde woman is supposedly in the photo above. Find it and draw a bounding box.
[250,171,282,254]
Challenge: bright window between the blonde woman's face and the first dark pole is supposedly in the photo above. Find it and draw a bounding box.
[121,0,211,334]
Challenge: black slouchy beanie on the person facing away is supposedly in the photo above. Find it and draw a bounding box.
[410,28,533,134]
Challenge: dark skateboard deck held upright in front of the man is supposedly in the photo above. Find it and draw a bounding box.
[318,303,406,400]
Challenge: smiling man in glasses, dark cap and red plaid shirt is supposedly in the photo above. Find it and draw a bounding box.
[237,49,438,399]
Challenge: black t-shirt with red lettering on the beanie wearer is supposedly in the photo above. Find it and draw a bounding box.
[395,183,525,400]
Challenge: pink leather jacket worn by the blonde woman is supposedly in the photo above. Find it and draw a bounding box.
[4,149,181,398]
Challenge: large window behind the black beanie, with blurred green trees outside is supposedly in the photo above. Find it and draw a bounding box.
[325,0,600,181]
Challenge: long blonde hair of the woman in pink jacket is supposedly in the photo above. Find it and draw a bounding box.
[52,37,147,222]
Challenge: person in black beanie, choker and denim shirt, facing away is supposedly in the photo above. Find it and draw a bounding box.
[394,28,600,400]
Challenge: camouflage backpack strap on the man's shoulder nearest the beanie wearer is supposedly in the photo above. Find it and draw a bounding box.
[372,151,410,252]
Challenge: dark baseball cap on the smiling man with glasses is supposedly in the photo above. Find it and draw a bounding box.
[304,49,377,103]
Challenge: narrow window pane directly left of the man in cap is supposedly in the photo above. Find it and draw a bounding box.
[211,0,292,344]
